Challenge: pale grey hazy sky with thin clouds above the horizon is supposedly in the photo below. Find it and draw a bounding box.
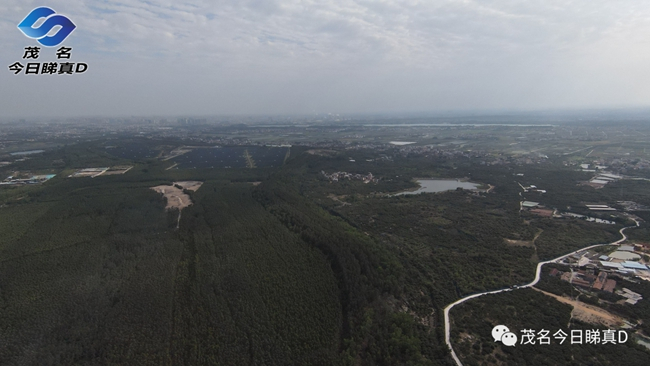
[0,0,650,117]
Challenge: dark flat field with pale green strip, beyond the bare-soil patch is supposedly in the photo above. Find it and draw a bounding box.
[172,146,287,169]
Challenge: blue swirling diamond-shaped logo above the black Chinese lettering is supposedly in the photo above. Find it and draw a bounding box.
[18,6,77,47]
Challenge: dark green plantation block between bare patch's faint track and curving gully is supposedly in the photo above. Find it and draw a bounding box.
[170,183,342,365]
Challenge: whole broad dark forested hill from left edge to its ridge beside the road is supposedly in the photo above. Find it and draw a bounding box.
[0,150,449,365]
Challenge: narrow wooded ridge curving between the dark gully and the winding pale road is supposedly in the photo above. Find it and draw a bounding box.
[255,176,450,364]
